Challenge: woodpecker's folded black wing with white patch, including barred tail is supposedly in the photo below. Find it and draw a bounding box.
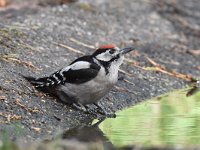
[24,56,100,89]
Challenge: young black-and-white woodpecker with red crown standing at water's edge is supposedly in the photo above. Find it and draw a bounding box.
[24,44,135,115]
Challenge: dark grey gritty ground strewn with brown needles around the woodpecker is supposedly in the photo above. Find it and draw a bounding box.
[0,0,200,140]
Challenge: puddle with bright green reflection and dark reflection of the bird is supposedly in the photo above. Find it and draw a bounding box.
[63,84,200,149]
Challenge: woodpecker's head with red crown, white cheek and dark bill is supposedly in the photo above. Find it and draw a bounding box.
[92,44,135,66]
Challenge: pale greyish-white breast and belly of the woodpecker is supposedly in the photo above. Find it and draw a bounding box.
[57,67,118,105]
